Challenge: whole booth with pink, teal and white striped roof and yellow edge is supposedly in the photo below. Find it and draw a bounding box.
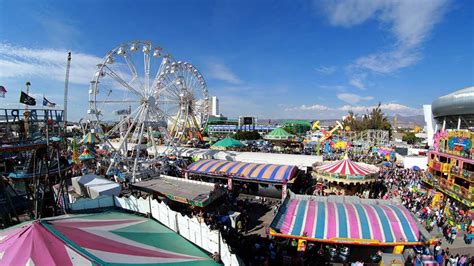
[270,191,436,262]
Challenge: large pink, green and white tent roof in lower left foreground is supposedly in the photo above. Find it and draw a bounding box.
[0,212,218,265]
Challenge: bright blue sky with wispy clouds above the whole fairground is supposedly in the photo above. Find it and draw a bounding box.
[0,0,474,120]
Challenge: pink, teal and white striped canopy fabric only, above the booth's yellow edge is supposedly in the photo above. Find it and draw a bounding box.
[270,198,420,243]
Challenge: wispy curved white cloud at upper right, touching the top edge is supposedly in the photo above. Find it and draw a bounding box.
[323,0,448,74]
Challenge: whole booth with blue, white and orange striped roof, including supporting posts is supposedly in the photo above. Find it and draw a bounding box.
[186,159,299,198]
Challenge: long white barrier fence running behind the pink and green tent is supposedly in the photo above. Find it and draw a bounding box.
[70,196,243,266]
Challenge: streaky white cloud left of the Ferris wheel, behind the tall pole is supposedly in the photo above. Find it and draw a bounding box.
[0,43,102,85]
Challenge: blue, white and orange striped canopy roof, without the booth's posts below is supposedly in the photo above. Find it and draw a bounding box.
[188,159,297,183]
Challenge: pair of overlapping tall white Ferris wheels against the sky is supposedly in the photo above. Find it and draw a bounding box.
[88,41,209,181]
